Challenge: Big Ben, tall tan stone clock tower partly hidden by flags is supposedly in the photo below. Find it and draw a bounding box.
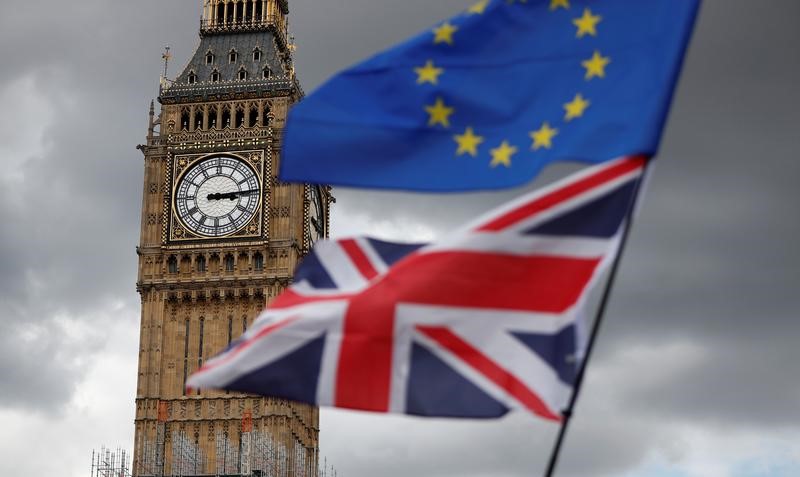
[133,0,332,476]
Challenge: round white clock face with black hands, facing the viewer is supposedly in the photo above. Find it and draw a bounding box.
[175,155,261,237]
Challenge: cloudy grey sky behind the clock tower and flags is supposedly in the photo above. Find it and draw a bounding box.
[0,0,800,477]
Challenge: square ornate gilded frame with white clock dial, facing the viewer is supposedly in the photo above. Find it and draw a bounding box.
[169,151,265,241]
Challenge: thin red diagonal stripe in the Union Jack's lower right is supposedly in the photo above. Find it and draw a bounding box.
[416,325,561,421]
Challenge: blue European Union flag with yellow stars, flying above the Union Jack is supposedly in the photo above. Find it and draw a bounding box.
[281,0,699,191]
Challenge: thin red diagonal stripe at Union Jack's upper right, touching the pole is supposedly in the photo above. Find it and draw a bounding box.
[478,156,647,232]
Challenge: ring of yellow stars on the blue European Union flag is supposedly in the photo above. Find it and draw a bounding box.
[414,0,611,168]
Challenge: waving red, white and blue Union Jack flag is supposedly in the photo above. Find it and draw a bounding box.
[187,157,645,421]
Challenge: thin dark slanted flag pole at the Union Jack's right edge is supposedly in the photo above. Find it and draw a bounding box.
[545,158,652,477]
